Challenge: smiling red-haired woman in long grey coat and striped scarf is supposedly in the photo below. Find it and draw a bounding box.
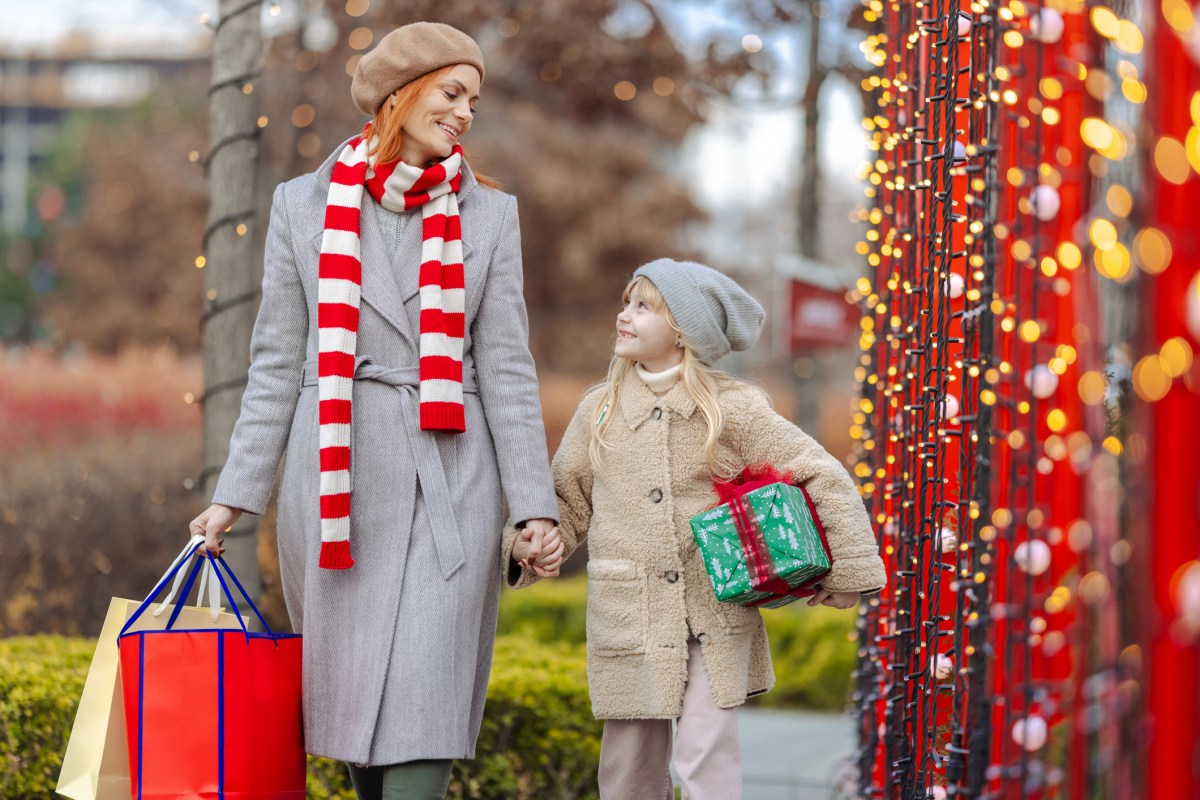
[191,23,560,798]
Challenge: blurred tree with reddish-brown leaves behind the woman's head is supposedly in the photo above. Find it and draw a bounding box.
[256,0,751,374]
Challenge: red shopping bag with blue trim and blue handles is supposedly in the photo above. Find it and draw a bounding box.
[118,545,306,800]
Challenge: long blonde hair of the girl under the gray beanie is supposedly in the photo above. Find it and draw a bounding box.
[588,276,743,479]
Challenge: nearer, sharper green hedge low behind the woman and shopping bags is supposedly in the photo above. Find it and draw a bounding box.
[0,636,600,800]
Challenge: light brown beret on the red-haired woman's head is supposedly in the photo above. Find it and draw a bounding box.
[350,23,484,115]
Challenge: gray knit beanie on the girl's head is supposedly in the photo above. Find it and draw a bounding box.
[634,258,766,363]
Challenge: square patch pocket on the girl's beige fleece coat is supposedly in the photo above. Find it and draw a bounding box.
[587,559,649,656]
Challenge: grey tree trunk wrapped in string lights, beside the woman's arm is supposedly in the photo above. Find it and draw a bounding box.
[200,0,263,606]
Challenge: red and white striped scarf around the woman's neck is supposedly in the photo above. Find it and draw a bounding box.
[317,125,467,570]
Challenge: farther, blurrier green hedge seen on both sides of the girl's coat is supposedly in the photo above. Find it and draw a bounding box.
[499,577,857,710]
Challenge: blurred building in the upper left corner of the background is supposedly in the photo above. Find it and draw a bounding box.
[0,25,211,233]
